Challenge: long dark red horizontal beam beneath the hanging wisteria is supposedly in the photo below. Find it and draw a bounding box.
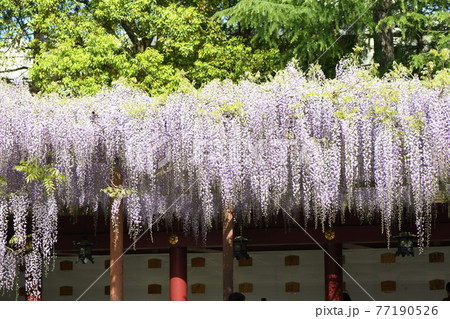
[56,204,450,252]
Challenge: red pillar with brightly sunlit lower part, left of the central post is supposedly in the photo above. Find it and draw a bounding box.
[169,247,187,301]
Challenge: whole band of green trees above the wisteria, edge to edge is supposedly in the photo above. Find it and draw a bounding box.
[0,0,450,95]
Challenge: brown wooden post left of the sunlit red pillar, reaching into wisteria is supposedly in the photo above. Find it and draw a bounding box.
[109,165,123,301]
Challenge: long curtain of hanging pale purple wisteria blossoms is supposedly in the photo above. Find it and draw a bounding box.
[0,61,450,296]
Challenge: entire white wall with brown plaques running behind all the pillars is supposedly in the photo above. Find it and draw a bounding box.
[0,247,450,301]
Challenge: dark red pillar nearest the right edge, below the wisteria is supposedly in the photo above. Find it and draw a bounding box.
[324,241,343,301]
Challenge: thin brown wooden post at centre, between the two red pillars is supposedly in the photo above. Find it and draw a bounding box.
[222,204,234,301]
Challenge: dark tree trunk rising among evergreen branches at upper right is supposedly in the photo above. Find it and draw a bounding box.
[373,0,394,75]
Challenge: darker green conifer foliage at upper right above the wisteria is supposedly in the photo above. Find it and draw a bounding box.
[215,0,450,76]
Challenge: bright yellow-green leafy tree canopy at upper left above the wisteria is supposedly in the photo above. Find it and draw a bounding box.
[0,0,277,95]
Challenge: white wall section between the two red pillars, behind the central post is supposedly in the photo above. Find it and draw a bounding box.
[188,250,324,301]
